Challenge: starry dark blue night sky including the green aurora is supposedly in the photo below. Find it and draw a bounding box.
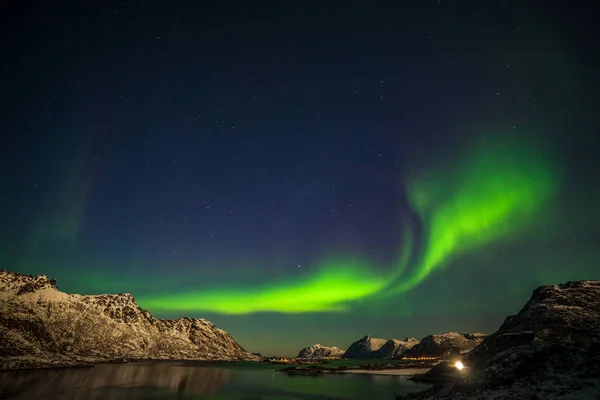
[0,0,600,355]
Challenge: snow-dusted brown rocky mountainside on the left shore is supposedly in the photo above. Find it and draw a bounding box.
[0,271,255,369]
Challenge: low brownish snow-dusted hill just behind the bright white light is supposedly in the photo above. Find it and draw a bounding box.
[402,332,487,358]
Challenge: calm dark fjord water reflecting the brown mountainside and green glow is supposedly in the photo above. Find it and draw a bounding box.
[0,362,429,400]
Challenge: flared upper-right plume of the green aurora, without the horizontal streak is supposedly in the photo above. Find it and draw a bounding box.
[395,137,557,292]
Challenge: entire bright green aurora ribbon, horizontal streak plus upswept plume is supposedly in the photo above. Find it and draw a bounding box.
[138,137,558,314]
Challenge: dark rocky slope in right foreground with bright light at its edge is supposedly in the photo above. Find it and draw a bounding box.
[398,281,600,400]
